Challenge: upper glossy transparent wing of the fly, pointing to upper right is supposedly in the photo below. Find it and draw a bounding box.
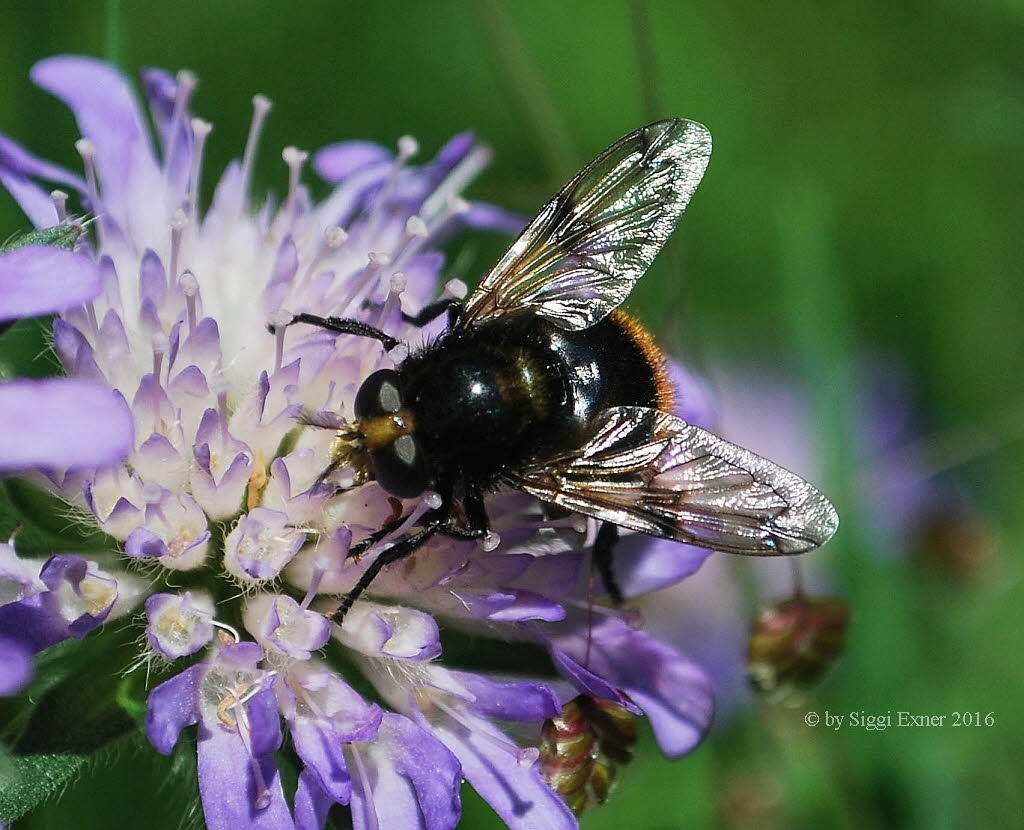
[459,119,711,331]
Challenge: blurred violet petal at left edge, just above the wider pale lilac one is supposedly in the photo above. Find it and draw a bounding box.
[0,245,100,320]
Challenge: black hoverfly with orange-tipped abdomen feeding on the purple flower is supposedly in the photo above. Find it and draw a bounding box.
[289,119,839,623]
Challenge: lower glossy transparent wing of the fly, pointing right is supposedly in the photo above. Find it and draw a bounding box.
[513,406,839,556]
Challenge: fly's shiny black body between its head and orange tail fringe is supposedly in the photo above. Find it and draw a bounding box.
[399,314,658,487]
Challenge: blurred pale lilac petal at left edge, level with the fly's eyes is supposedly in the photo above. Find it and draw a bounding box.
[0,379,134,471]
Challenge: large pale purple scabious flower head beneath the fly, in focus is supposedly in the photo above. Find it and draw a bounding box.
[0,57,712,829]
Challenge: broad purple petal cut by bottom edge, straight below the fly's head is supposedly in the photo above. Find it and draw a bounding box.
[352,712,462,830]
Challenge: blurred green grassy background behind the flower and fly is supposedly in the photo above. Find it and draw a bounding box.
[0,0,1024,830]
